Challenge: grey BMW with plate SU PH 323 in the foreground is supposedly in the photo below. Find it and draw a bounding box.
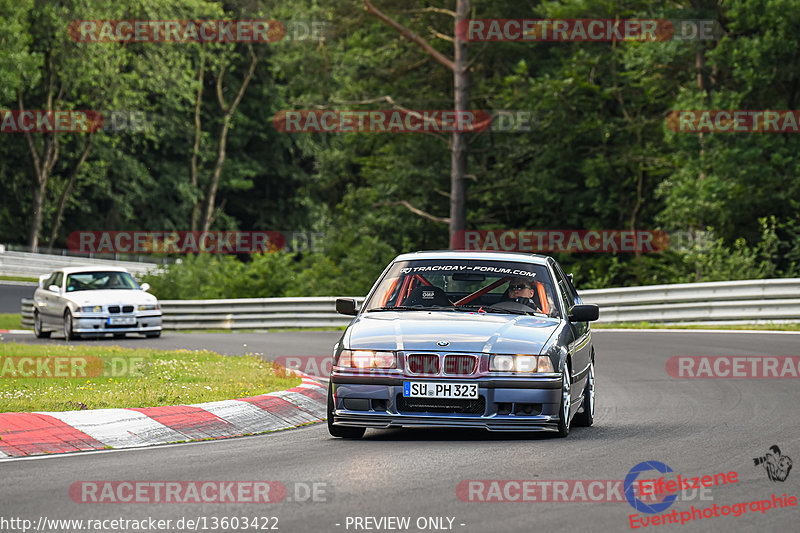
[328,251,598,438]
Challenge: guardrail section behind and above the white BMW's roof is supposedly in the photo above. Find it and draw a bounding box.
[0,250,160,278]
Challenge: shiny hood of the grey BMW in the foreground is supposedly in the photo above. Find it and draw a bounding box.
[344,311,561,354]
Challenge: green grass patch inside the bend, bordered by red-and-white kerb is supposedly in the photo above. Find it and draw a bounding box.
[0,343,300,412]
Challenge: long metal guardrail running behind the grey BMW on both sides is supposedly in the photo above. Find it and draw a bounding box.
[17,278,800,329]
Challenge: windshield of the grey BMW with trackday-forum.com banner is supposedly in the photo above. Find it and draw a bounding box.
[364,259,560,318]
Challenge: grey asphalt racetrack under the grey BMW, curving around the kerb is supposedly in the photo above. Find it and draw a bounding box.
[0,330,800,533]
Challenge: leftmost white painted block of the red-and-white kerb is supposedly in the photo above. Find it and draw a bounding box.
[42,409,191,448]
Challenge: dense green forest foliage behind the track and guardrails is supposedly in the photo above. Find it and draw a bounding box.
[0,0,800,297]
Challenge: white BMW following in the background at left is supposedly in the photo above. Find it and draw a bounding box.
[33,266,161,339]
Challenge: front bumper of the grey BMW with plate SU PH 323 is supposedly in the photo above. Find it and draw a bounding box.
[331,371,561,431]
